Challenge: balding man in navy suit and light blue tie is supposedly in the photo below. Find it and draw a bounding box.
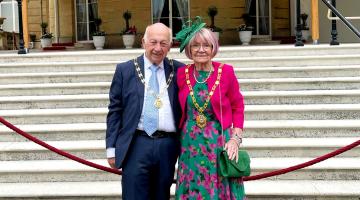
[106,23,184,200]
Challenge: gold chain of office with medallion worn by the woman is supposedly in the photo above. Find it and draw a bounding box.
[185,64,224,128]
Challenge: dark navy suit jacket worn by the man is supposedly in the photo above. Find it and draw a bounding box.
[106,55,184,168]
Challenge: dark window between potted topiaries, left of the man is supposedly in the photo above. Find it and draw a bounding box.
[75,0,98,41]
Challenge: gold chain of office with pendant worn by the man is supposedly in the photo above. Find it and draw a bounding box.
[134,58,174,109]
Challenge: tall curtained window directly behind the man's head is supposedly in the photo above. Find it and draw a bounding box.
[152,0,190,35]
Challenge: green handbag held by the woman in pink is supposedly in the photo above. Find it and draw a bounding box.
[218,149,250,178]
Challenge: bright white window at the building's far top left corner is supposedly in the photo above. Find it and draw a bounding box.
[0,0,19,33]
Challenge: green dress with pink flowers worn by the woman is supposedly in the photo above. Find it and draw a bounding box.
[176,71,244,200]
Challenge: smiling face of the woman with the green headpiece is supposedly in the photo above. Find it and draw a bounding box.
[190,37,213,64]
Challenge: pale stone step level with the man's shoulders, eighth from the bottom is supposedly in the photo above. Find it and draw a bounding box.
[0,65,360,85]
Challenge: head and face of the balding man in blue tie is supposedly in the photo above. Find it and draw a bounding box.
[142,24,171,65]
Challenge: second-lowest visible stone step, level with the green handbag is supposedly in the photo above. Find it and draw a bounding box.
[0,157,360,183]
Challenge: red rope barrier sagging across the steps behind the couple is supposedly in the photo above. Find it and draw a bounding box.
[0,117,360,181]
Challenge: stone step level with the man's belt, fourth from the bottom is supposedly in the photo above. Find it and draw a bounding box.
[0,120,360,142]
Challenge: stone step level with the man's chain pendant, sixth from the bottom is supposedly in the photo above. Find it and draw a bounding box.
[0,90,360,110]
